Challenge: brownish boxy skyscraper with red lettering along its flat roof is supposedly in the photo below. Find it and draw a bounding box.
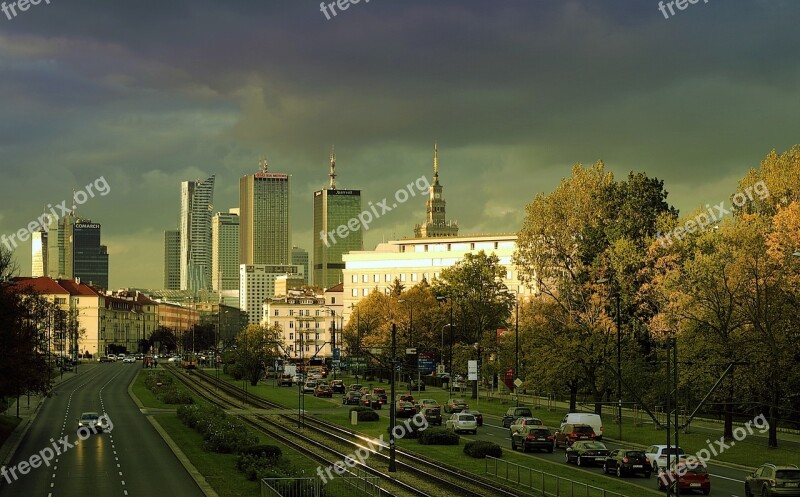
[239,160,292,264]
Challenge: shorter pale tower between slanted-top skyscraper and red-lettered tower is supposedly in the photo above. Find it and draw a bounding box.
[211,209,239,291]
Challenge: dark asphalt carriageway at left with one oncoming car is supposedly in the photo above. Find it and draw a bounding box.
[0,362,203,497]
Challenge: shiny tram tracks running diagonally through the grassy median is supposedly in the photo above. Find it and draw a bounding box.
[163,368,528,497]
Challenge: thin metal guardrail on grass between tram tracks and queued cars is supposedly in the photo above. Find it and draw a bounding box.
[486,456,626,497]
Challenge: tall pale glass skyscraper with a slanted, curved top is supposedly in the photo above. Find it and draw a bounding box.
[180,176,215,291]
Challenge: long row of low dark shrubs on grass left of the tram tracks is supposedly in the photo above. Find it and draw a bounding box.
[178,405,258,454]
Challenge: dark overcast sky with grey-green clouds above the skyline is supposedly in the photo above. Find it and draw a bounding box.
[0,0,800,288]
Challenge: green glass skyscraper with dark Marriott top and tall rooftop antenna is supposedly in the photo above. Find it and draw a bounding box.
[313,145,364,290]
